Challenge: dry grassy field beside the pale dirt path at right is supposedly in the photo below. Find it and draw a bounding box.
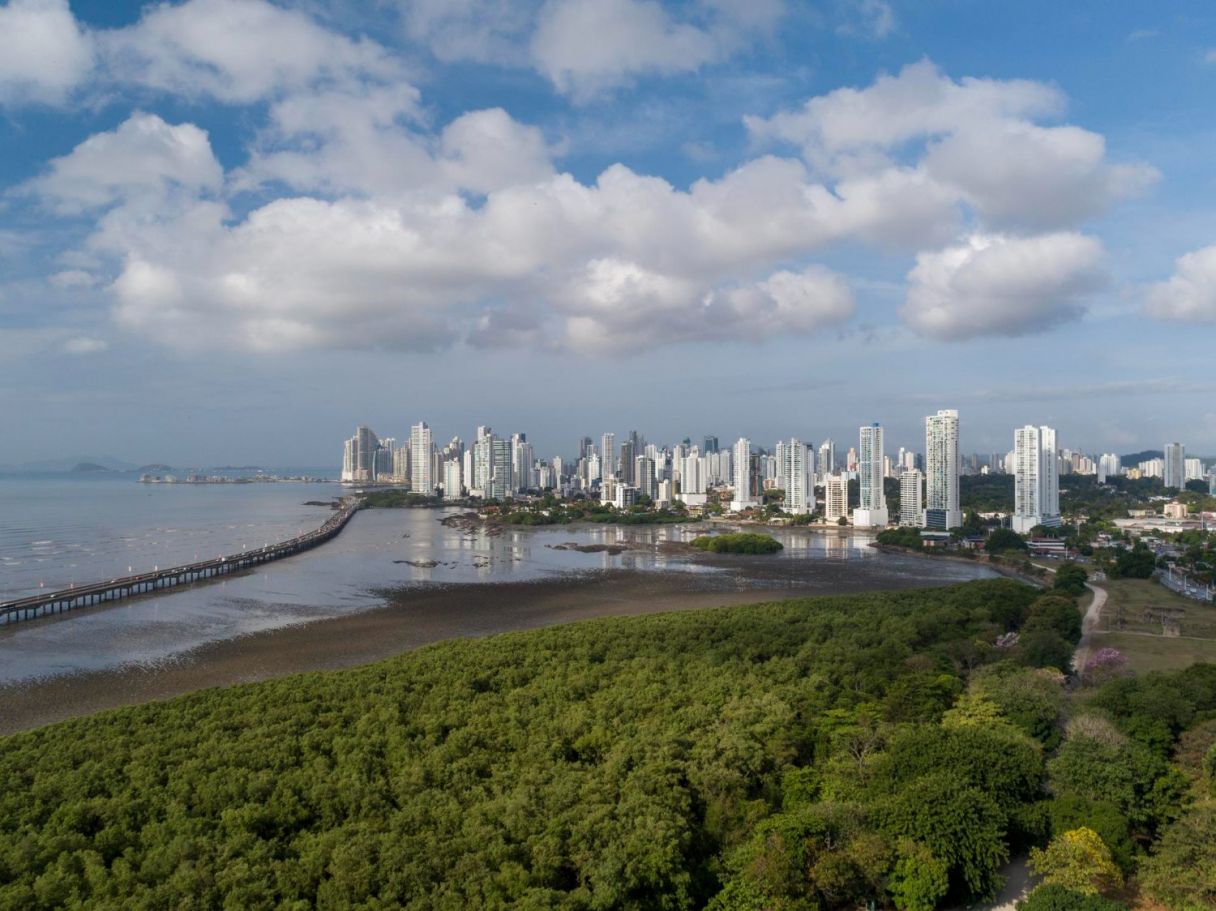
[1093,579,1216,674]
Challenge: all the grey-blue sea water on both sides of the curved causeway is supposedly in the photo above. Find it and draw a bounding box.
[0,477,991,685]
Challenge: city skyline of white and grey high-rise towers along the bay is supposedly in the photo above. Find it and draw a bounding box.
[340,409,1216,534]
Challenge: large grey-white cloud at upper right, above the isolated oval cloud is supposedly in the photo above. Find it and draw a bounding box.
[745,61,1156,231]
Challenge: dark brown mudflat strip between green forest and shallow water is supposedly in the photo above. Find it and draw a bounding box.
[0,557,992,736]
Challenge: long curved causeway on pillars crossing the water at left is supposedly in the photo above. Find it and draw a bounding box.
[0,502,359,626]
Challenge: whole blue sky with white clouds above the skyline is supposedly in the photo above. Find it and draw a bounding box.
[0,0,1216,465]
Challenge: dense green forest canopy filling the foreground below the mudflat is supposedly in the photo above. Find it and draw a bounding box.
[0,579,1216,911]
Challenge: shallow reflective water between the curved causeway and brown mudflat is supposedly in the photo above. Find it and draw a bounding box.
[0,510,991,684]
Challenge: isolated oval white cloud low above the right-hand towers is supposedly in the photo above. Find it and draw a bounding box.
[900,232,1105,341]
